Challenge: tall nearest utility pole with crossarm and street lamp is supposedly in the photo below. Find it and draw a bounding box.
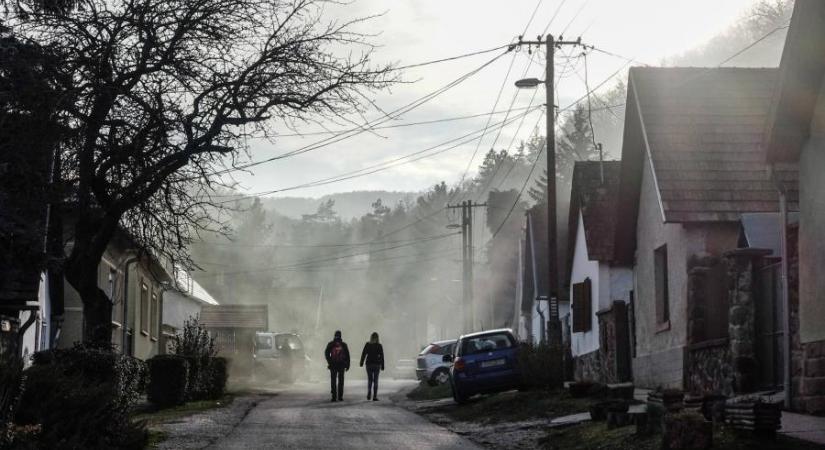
[515,34,584,385]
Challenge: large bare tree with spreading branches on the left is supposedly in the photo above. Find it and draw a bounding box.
[7,0,395,342]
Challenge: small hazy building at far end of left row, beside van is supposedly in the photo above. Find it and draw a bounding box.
[200,305,269,374]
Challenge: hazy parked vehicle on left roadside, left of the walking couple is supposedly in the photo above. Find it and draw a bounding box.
[253,332,309,383]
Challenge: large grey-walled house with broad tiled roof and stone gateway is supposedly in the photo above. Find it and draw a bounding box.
[613,64,798,393]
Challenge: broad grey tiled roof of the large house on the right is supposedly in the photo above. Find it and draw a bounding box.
[628,67,798,222]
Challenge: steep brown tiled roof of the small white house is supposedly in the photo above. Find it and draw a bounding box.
[567,161,622,270]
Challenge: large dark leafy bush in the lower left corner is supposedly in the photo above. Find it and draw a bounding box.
[15,345,147,449]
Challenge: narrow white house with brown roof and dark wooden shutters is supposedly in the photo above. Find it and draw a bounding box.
[567,161,633,383]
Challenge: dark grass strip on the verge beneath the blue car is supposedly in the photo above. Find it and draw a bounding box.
[445,390,596,423]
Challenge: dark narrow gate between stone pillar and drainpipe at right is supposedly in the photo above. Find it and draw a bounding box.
[754,263,785,389]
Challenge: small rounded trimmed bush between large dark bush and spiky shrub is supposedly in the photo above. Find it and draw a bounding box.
[147,355,189,408]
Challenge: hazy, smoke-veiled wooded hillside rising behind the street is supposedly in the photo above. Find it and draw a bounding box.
[191,1,793,384]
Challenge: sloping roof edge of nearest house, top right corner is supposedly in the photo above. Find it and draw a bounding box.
[766,0,825,161]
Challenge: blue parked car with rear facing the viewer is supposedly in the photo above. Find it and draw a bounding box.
[443,329,521,403]
